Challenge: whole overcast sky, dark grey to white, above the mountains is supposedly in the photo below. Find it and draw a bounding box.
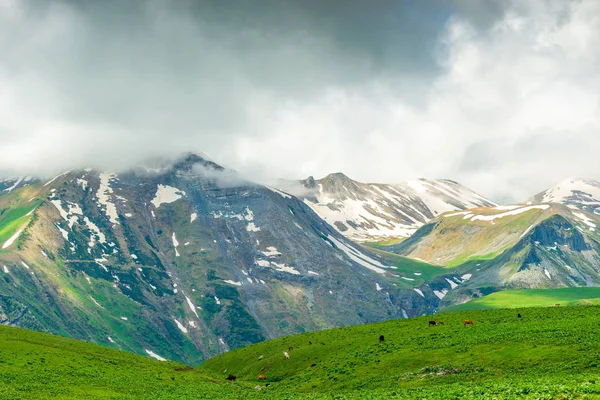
[0,0,600,201]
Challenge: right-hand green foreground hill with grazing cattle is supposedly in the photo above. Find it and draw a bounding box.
[200,306,600,399]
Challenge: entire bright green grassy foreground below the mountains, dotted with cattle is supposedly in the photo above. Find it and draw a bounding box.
[5,306,600,399]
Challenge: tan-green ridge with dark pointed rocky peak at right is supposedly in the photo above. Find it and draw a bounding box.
[387,203,600,306]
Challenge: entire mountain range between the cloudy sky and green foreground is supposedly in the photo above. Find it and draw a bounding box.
[0,154,600,364]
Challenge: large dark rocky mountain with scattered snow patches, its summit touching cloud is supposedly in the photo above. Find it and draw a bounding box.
[0,155,428,363]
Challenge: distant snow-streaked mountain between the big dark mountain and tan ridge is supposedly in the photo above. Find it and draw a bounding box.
[275,173,495,241]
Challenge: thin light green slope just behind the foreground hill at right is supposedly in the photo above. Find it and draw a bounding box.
[443,287,600,312]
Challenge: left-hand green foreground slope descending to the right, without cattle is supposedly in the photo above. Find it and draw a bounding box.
[0,325,239,400]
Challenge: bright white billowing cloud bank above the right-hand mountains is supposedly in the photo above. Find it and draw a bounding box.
[227,1,600,200]
